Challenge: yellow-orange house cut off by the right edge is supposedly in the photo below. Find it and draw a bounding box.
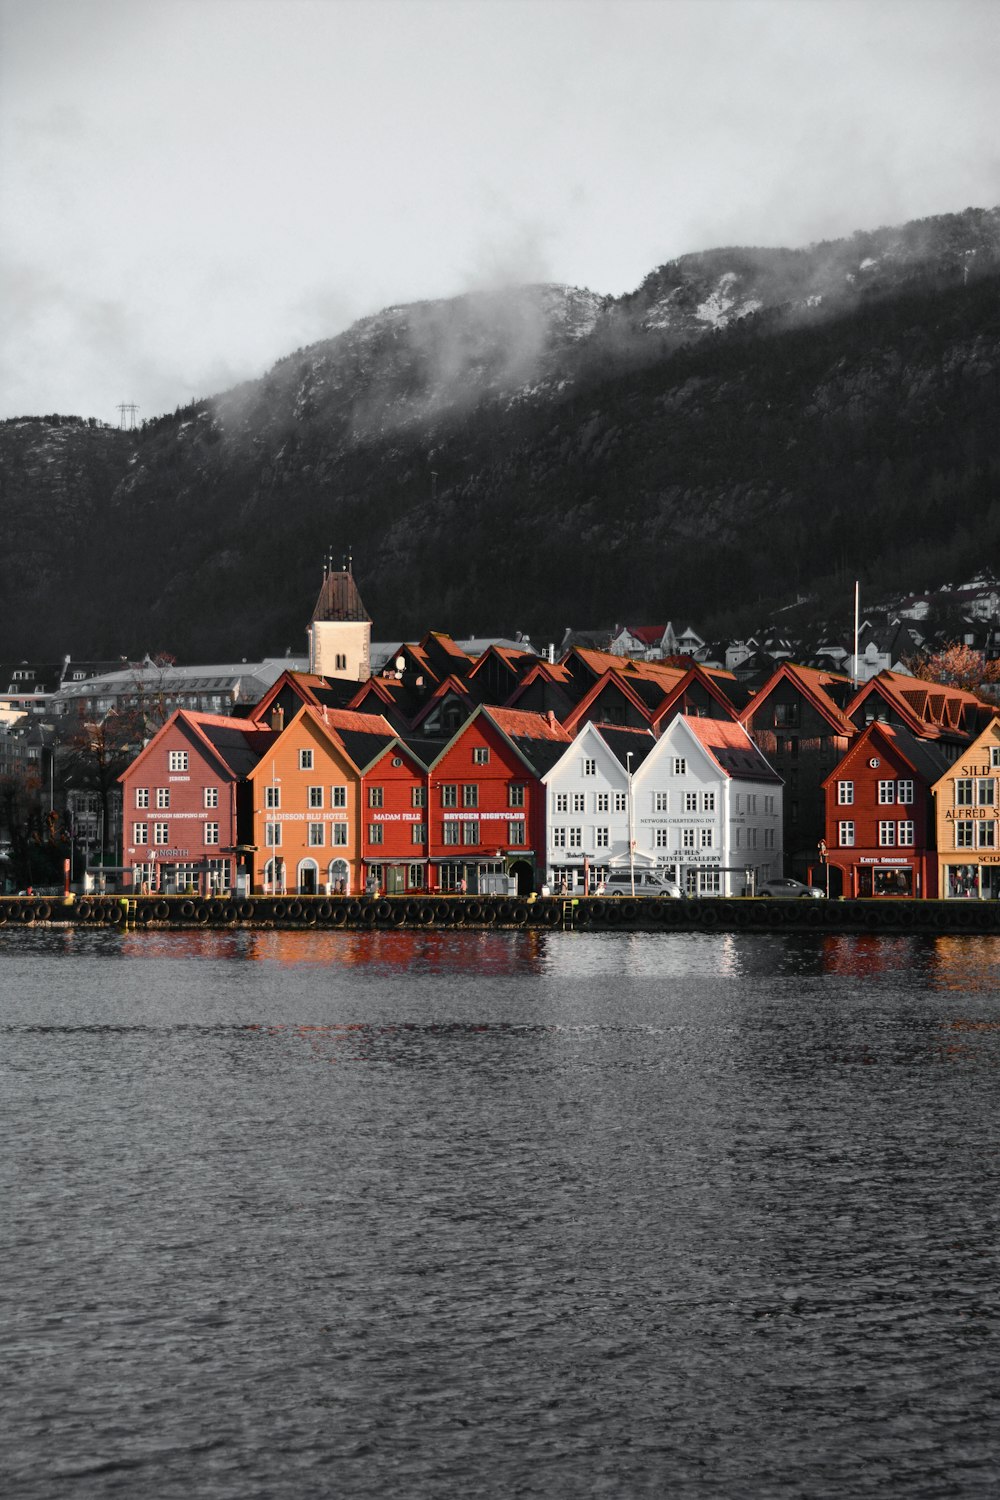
[933,719,1000,900]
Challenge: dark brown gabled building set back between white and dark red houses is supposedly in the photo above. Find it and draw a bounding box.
[739,662,858,882]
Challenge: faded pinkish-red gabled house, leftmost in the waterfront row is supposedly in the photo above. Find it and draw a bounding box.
[120,710,277,894]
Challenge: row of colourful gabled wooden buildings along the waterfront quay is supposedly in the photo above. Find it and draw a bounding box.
[113,585,1000,897]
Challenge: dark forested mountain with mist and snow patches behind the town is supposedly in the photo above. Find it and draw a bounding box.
[0,209,1000,660]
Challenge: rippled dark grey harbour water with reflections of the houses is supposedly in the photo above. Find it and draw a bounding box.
[0,930,1000,1500]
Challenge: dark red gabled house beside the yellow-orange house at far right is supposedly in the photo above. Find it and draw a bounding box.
[825,720,948,897]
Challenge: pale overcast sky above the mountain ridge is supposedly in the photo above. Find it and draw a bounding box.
[0,0,1000,425]
